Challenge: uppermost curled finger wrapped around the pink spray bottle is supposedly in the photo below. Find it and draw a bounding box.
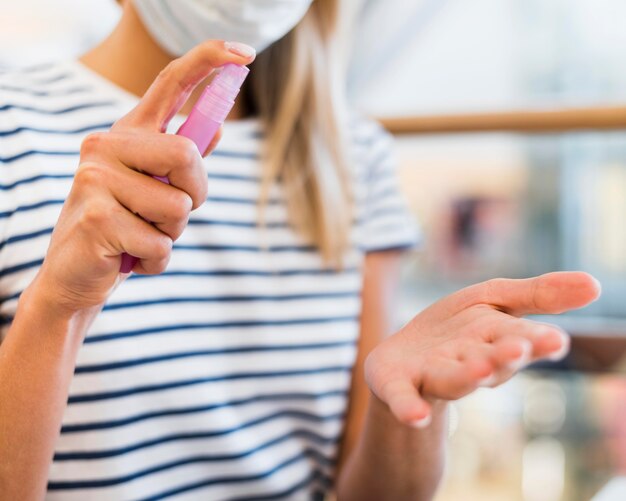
[81,132,208,209]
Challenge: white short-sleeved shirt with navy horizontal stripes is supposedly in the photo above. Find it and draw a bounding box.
[0,62,416,500]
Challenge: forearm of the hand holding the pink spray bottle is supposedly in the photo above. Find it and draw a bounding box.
[0,285,98,500]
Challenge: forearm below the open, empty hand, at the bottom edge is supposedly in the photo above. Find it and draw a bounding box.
[337,396,447,501]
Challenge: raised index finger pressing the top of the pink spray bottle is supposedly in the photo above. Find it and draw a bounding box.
[114,40,255,132]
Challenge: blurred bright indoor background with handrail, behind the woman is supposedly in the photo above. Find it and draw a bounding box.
[0,0,626,501]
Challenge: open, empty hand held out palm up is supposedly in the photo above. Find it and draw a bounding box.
[365,272,600,426]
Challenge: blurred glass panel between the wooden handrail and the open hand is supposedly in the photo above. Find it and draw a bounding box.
[397,133,626,328]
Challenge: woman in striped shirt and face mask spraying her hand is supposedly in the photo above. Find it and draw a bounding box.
[0,0,599,501]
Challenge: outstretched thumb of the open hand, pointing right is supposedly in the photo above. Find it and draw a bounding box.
[444,272,601,316]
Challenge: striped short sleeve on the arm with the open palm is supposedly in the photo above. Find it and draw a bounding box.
[359,119,421,253]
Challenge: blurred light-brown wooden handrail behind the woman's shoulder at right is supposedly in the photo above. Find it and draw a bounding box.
[380,106,626,134]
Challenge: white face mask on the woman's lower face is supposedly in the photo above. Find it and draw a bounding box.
[133,0,313,56]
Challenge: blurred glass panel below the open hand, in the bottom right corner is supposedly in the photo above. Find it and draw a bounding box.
[436,372,626,501]
